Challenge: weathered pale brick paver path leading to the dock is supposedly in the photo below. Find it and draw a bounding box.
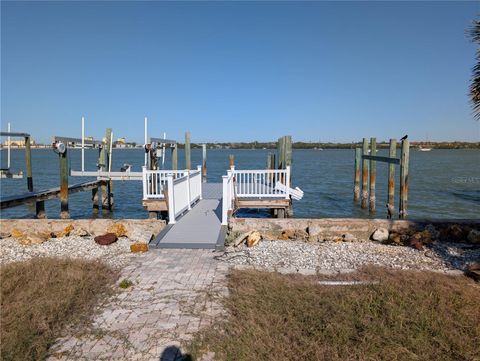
[50,249,228,361]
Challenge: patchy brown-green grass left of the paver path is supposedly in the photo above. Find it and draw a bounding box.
[0,258,117,360]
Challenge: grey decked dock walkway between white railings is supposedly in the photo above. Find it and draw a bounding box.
[150,183,226,250]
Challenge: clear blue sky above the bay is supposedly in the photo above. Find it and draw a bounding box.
[1,1,480,143]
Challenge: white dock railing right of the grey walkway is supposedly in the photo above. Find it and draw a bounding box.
[222,167,290,225]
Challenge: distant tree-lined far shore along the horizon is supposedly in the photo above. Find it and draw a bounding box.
[0,141,480,150]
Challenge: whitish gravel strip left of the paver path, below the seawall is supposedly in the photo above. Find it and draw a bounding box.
[0,236,136,268]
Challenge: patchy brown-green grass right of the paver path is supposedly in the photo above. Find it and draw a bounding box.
[189,268,480,361]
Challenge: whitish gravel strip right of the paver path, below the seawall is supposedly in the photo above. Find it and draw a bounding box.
[217,240,480,272]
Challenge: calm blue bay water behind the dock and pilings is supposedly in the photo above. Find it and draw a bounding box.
[0,149,480,218]
